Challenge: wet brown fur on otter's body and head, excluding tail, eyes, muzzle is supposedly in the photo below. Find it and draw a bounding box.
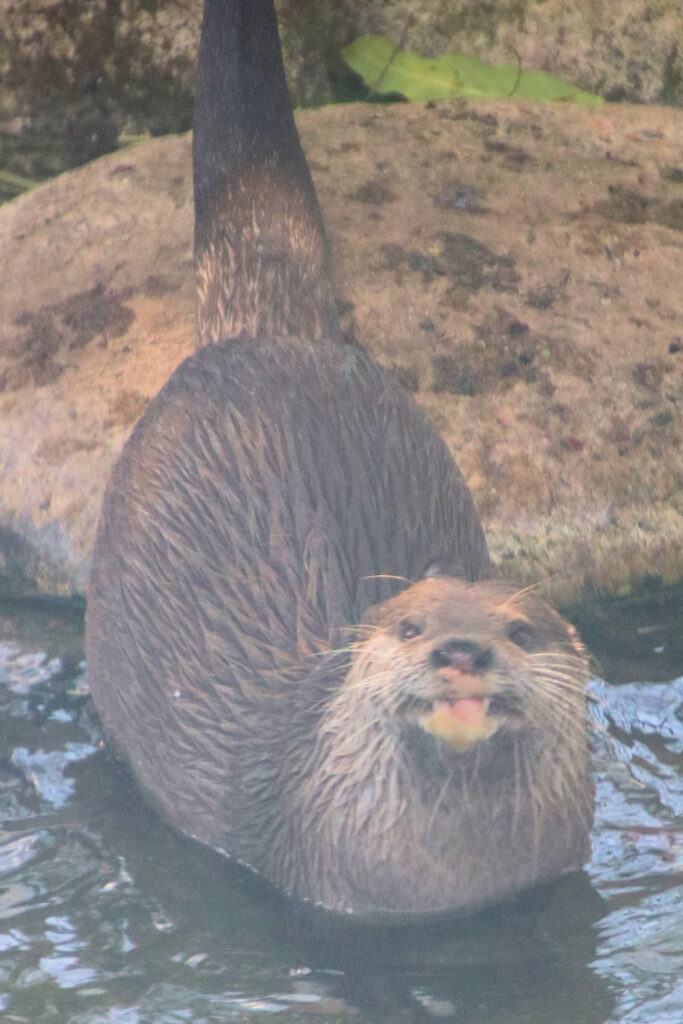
[87,339,591,913]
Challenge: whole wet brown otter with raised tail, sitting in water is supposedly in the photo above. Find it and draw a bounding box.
[86,0,592,915]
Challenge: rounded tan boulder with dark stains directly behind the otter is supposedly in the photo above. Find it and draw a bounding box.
[0,101,683,598]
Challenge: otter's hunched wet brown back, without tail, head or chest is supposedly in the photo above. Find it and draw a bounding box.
[86,338,488,872]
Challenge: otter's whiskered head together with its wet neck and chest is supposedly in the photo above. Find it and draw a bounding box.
[288,577,593,911]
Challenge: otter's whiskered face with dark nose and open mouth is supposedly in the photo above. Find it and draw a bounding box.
[352,577,588,752]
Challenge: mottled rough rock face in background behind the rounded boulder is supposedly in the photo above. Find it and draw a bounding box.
[0,0,683,186]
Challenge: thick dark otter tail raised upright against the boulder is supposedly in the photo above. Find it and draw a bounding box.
[193,0,339,347]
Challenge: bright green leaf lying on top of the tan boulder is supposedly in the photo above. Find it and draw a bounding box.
[342,36,603,103]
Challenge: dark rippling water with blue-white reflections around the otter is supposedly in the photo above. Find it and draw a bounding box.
[0,592,683,1024]
